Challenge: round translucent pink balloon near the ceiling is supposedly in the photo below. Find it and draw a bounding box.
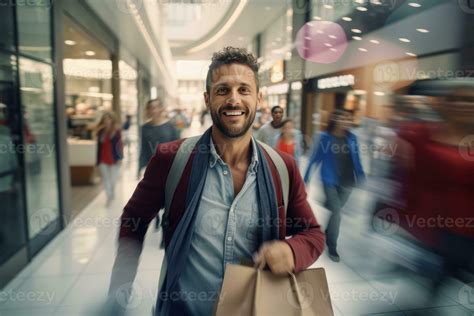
[295,21,347,64]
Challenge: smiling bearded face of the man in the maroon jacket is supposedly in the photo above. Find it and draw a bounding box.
[204,64,262,138]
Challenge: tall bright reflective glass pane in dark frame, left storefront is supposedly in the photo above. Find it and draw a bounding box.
[19,57,60,239]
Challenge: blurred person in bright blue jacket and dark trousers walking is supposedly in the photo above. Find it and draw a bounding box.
[304,110,365,262]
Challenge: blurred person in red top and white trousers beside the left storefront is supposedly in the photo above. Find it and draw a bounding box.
[97,112,123,205]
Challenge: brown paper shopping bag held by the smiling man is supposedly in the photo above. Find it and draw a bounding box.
[215,264,333,316]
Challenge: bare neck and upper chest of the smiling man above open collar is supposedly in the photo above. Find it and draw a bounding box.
[211,127,252,167]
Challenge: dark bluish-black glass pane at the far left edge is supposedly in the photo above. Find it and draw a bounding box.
[0,53,26,264]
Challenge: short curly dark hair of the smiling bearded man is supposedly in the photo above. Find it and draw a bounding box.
[206,46,259,94]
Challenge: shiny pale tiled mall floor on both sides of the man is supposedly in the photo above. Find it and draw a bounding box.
[0,124,474,316]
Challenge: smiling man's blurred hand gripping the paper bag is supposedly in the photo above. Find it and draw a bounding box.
[254,240,295,275]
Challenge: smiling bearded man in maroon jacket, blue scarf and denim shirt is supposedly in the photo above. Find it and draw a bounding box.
[110,47,324,315]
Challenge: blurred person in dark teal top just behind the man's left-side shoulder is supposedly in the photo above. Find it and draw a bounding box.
[137,99,179,179]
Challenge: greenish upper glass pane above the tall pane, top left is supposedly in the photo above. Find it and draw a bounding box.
[16,0,52,62]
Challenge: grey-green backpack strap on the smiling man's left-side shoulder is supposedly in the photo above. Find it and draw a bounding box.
[163,135,201,223]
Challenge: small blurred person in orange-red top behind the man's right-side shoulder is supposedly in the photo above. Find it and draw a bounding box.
[275,119,303,166]
